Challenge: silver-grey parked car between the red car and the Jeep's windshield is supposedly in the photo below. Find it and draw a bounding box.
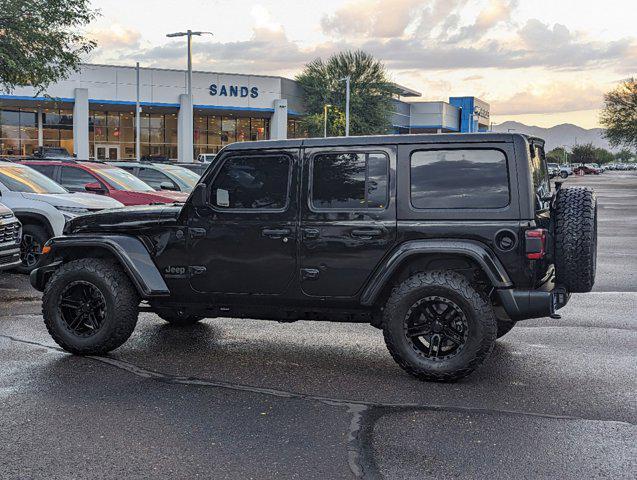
[110,162,200,193]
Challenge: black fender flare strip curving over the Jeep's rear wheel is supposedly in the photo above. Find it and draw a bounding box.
[360,240,513,306]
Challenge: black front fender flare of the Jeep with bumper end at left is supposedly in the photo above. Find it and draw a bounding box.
[30,234,170,298]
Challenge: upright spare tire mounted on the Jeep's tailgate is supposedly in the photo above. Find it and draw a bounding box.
[553,187,597,293]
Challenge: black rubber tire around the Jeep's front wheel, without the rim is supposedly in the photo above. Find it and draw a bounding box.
[42,258,140,355]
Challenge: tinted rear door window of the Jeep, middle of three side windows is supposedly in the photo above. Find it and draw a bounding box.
[312,153,389,210]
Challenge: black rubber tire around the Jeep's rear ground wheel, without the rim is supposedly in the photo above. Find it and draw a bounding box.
[383,271,497,382]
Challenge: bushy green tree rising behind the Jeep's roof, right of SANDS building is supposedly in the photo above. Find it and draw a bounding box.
[296,50,397,137]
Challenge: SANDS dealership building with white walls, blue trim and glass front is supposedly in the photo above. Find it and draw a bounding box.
[0,64,489,160]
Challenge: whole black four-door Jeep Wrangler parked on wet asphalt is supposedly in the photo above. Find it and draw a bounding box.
[31,134,597,381]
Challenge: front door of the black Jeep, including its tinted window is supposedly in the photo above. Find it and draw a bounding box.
[188,149,299,295]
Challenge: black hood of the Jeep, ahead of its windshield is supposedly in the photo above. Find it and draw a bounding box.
[64,205,181,234]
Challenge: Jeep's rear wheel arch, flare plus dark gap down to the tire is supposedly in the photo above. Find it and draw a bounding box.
[360,240,513,306]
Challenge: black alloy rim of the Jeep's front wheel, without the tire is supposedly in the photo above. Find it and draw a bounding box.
[58,280,106,337]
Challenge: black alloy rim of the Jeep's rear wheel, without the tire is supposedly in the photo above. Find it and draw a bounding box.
[404,296,469,361]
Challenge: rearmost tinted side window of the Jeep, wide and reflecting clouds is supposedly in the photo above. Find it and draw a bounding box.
[411,150,509,208]
